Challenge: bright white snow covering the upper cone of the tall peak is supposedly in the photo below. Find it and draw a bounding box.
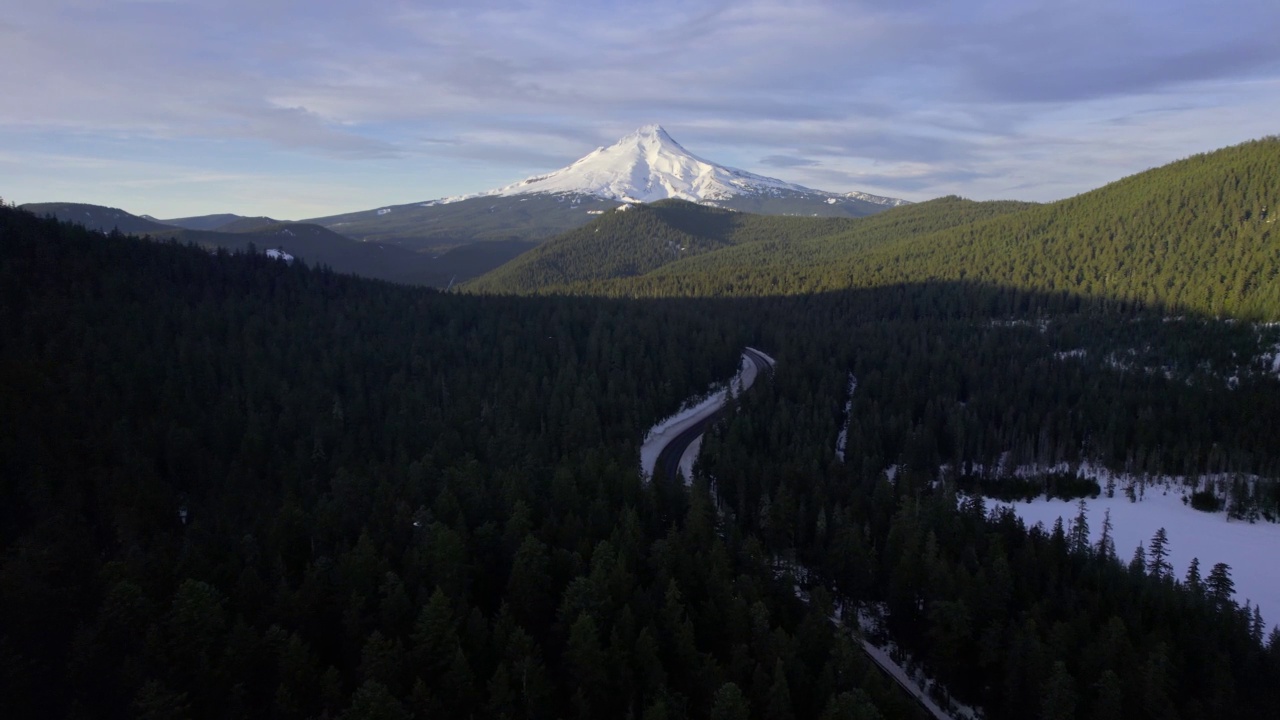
[428,126,906,208]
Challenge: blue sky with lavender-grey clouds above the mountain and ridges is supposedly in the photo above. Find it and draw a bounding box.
[0,0,1280,219]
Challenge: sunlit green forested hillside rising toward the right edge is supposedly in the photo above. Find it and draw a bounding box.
[476,138,1280,318]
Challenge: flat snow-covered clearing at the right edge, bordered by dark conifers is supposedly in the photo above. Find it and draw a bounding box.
[996,484,1280,624]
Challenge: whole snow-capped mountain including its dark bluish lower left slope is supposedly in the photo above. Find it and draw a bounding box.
[303,126,906,274]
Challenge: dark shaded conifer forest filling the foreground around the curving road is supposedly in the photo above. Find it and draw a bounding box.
[0,159,1280,719]
